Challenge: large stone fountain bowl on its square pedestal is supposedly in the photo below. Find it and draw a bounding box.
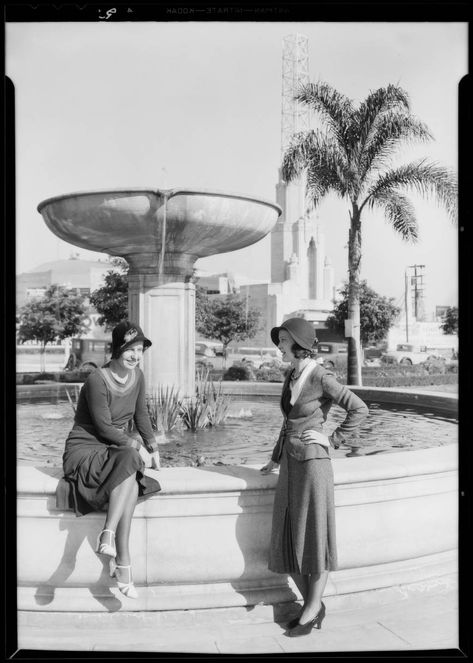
[38,189,281,396]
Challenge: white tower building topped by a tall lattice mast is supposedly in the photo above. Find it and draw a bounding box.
[207,34,334,346]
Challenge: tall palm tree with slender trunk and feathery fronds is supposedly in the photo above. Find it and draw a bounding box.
[281,82,457,385]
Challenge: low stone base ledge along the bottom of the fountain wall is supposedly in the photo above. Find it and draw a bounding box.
[18,550,458,626]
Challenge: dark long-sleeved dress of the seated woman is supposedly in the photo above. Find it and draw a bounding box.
[56,365,161,516]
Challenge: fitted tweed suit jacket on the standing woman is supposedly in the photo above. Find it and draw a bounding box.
[271,364,368,463]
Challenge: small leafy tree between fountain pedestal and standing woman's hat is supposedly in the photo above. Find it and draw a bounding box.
[196,294,261,356]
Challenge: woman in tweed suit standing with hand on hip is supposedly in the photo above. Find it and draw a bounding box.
[261,318,368,637]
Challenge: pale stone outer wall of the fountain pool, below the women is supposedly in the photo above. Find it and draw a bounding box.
[17,436,458,613]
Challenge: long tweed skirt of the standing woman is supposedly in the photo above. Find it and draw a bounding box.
[268,446,337,575]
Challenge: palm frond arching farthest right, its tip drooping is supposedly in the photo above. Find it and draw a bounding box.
[363,159,458,221]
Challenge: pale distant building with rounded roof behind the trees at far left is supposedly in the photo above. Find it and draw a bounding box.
[16,257,111,307]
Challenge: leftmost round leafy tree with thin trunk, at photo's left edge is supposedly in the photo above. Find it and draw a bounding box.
[18,285,87,372]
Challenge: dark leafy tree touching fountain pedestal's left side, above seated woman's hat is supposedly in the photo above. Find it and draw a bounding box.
[90,258,128,329]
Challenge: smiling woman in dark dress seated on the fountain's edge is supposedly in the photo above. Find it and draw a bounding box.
[57,321,161,598]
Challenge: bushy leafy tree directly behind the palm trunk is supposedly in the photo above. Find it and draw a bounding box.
[326,281,400,345]
